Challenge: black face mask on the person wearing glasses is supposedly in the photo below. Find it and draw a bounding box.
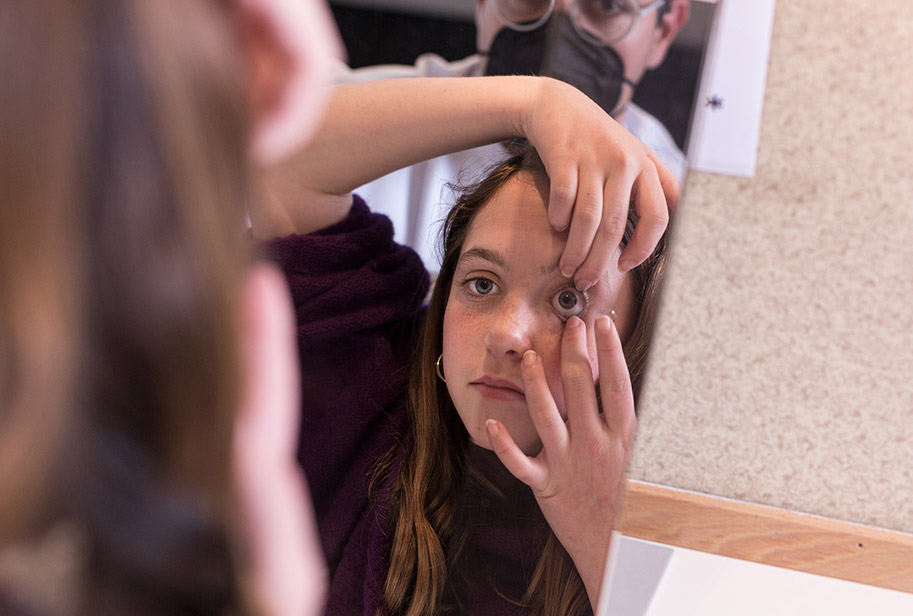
[485,12,635,113]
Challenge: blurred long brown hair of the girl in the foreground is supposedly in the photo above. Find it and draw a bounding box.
[0,0,249,614]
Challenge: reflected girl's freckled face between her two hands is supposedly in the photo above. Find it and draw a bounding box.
[442,173,635,455]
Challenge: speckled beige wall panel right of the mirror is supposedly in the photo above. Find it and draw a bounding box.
[632,0,913,532]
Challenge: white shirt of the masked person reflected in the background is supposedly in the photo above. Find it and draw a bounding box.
[337,53,686,273]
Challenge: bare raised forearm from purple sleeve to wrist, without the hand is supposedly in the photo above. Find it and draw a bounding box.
[251,77,551,237]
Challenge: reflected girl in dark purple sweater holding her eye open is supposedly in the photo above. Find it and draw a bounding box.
[251,77,676,615]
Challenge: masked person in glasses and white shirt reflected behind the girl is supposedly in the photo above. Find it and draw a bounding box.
[337,0,691,271]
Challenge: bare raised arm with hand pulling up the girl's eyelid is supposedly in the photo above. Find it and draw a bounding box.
[251,77,678,287]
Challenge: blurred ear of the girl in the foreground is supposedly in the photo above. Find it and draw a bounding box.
[234,0,343,166]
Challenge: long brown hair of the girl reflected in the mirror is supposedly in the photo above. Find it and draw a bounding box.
[383,144,665,616]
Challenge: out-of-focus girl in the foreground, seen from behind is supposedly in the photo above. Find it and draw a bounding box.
[0,0,333,616]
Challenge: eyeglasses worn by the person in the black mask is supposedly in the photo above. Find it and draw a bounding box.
[494,0,667,45]
